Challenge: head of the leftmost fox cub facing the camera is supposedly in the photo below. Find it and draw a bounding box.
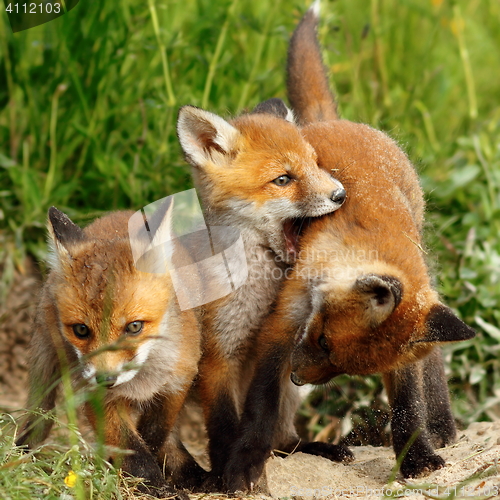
[48,201,189,399]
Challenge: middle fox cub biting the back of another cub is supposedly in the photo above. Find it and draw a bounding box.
[177,99,345,487]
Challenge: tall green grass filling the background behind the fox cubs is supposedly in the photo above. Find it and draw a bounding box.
[0,0,500,498]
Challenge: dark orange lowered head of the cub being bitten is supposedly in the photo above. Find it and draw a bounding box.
[292,270,475,385]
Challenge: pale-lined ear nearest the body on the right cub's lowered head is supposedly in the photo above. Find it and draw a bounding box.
[354,274,403,327]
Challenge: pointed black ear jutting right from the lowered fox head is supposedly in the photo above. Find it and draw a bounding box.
[419,304,476,342]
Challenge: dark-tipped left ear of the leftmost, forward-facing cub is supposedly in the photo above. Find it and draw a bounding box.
[48,207,85,268]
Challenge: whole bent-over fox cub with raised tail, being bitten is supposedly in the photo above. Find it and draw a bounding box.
[224,1,474,491]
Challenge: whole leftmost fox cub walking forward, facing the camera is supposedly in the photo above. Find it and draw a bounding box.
[17,203,200,497]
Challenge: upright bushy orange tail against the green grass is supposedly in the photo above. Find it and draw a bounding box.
[287,0,338,125]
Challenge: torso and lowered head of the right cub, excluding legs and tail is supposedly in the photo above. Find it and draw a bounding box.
[289,120,474,383]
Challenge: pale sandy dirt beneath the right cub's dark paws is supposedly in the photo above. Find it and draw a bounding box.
[258,422,500,500]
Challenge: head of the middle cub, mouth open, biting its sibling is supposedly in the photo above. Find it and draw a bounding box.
[177,99,346,262]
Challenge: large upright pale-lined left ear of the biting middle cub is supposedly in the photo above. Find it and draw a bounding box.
[177,106,240,168]
